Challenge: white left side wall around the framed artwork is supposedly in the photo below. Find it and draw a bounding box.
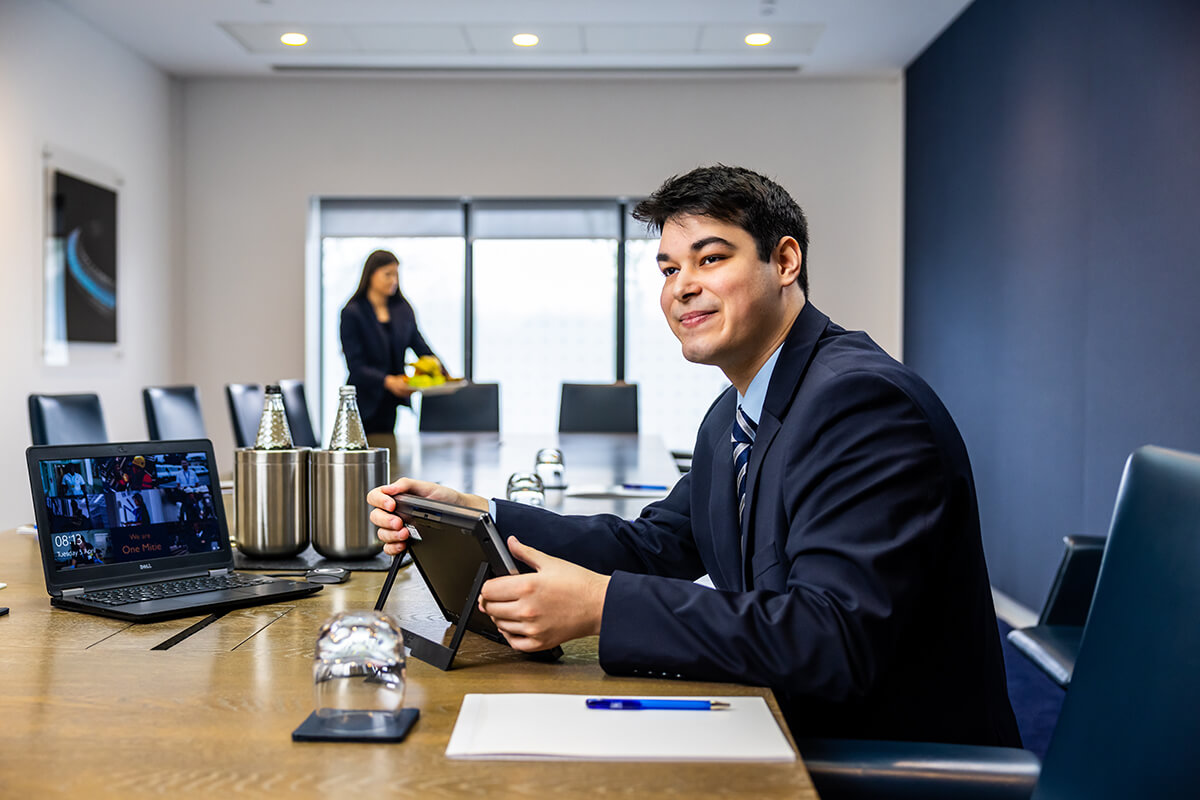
[0,0,179,529]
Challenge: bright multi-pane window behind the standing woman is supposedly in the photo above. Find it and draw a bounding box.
[308,199,728,450]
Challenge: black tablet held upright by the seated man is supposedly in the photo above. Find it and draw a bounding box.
[394,494,520,644]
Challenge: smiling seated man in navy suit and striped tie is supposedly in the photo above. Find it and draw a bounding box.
[368,166,1020,746]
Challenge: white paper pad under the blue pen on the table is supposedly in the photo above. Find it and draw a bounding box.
[446,694,796,762]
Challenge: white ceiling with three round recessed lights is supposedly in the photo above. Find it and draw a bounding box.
[56,0,970,77]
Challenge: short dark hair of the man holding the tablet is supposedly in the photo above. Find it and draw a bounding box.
[634,164,809,297]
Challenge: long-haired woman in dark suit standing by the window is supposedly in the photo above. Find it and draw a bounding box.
[341,249,436,469]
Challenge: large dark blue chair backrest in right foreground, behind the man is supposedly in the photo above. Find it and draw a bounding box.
[1033,447,1200,800]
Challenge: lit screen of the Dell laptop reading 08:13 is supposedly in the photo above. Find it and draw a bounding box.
[38,443,222,573]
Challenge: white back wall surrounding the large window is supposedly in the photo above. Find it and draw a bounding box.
[181,78,904,458]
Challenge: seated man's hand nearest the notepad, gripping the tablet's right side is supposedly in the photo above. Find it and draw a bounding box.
[479,536,608,652]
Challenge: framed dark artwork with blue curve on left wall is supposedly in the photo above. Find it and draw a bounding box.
[43,150,120,365]
